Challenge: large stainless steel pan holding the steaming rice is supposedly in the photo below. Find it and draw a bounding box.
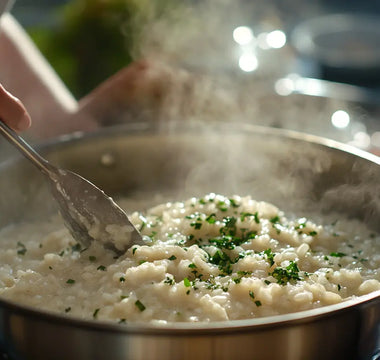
[0,123,380,360]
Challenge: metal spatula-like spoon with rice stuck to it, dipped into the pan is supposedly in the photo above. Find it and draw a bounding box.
[0,120,144,255]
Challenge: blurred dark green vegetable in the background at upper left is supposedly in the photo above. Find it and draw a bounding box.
[27,0,181,99]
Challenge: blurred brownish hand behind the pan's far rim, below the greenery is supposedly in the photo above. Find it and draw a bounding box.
[75,60,195,126]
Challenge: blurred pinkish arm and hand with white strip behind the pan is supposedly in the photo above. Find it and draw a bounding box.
[0,14,189,141]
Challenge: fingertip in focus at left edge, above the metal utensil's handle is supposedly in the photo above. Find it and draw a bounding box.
[0,84,31,131]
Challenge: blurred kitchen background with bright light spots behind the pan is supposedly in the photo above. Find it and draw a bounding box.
[6,0,380,154]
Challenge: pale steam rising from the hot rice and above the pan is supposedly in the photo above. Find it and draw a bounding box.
[90,0,380,232]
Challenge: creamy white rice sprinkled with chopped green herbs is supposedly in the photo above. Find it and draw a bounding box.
[0,194,380,323]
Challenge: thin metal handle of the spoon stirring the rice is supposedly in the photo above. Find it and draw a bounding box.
[0,120,51,176]
